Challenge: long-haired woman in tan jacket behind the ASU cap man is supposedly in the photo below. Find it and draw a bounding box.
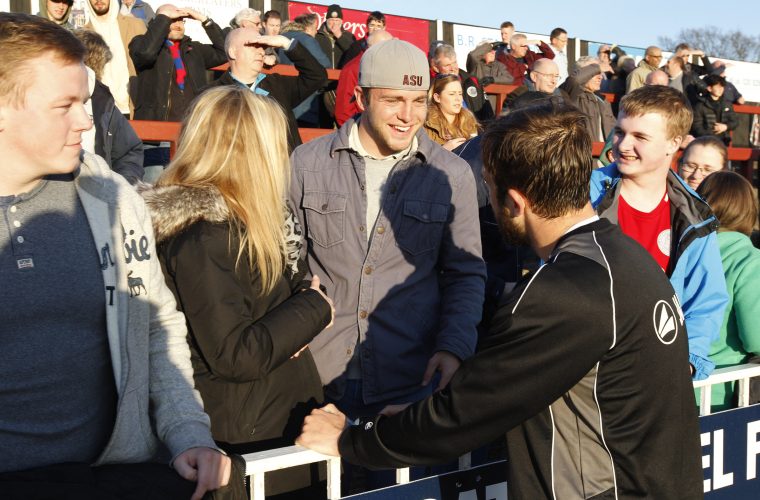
[425,74,478,151]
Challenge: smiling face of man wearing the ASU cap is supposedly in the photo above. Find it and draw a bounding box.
[355,87,427,157]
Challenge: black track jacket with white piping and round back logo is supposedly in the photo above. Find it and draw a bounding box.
[340,220,703,499]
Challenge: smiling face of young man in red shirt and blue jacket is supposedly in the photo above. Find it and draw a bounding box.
[612,109,682,178]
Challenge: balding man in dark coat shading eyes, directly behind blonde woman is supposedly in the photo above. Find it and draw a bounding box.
[211,28,327,151]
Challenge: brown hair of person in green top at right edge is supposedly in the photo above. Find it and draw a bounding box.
[697,170,757,236]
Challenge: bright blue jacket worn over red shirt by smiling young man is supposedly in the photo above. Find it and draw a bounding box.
[591,163,728,380]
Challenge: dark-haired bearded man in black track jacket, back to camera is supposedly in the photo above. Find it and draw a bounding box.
[297,103,702,499]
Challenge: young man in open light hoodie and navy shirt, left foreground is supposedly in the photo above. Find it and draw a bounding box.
[0,13,230,499]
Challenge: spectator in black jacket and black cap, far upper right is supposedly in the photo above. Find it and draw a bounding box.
[691,75,739,146]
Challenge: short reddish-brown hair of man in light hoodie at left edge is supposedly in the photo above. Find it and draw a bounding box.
[0,12,85,105]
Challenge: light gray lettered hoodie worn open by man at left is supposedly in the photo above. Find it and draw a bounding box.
[75,153,216,465]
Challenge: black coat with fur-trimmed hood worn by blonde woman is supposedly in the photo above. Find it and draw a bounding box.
[143,186,330,450]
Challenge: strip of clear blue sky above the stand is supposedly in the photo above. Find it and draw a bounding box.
[302,0,760,47]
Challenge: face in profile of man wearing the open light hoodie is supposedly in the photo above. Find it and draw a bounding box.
[0,55,92,194]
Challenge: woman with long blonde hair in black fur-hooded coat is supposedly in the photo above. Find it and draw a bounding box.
[145,86,334,492]
